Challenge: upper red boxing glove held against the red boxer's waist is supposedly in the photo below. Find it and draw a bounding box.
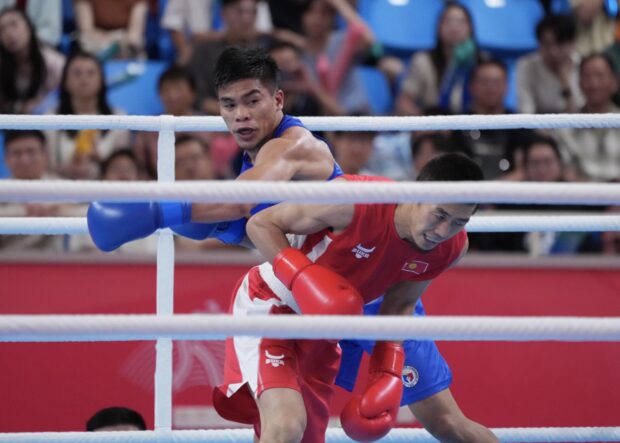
[273,248,364,315]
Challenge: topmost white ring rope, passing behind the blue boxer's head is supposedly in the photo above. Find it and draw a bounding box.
[0,113,620,132]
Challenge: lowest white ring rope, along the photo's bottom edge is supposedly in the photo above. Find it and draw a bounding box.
[0,427,620,443]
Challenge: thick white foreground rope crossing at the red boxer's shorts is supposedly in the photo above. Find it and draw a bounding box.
[0,314,620,342]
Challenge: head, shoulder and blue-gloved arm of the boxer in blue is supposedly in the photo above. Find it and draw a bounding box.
[87,47,342,251]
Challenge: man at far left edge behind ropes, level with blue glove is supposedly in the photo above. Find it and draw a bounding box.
[0,130,80,252]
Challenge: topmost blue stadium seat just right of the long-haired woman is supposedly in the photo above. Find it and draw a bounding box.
[460,0,544,55]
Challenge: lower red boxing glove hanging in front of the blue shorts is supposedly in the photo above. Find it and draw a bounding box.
[340,342,405,442]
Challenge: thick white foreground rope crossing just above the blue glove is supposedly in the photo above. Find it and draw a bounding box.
[0,180,620,205]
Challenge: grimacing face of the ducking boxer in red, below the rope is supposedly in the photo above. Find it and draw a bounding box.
[409,204,476,251]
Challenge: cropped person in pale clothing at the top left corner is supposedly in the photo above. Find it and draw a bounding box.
[0,0,62,47]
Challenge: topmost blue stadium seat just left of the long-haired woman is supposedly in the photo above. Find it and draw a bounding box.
[358,0,443,56]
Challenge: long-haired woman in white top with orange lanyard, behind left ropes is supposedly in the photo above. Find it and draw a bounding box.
[48,52,130,179]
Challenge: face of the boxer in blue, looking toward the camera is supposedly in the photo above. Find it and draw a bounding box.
[218,79,284,151]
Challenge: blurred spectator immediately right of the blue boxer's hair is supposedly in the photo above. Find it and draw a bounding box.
[269,42,344,116]
